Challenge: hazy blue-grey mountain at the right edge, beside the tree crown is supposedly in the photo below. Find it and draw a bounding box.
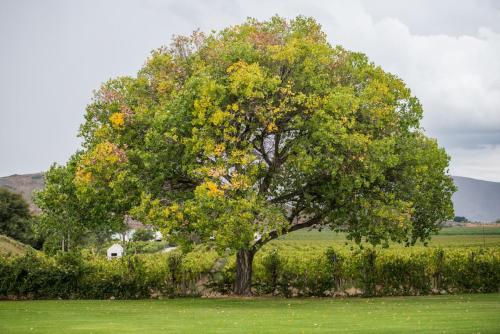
[452,176,500,222]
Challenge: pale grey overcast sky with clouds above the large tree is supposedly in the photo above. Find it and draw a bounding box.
[0,0,500,181]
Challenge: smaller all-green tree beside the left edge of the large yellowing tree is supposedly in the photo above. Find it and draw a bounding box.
[34,152,125,252]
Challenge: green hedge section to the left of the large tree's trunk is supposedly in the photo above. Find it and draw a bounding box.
[0,249,216,299]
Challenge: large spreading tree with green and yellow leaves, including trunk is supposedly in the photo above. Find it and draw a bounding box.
[63,17,454,294]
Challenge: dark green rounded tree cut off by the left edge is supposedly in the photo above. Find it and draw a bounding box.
[0,188,34,243]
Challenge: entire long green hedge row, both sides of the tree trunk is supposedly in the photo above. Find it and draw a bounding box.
[0,247,500,299]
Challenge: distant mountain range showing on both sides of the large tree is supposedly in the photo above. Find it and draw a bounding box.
[0,173,500,222]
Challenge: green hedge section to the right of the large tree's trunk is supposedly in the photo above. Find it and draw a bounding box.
[246,247,500,296]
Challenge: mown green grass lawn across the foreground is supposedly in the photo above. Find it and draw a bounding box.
[0,294,500,334]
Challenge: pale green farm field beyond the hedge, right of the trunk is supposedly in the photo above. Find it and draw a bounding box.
[270,226,500,248]
